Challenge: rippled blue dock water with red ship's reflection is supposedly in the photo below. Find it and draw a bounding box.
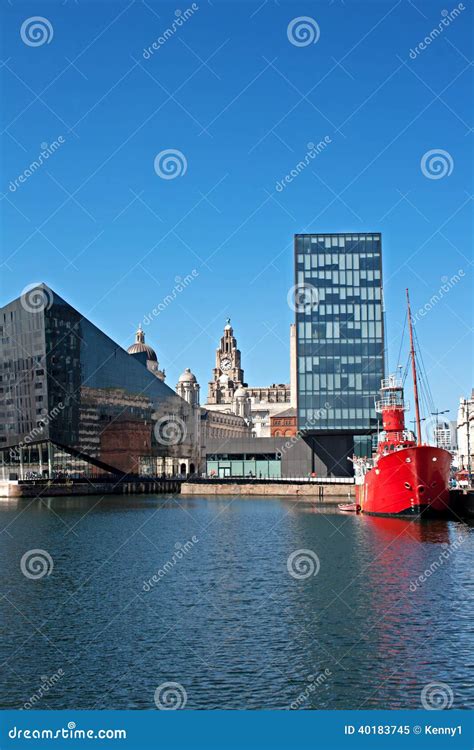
[0,496,474,710]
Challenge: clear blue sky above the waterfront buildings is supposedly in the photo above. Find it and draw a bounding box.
[0,0,472,426]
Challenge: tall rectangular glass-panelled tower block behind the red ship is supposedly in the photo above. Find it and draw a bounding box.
[292,232,384,476]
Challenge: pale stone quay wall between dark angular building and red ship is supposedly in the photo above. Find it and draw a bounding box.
[181,481,354,502]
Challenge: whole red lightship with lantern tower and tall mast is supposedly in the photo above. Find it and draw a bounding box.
[353,289,452,516]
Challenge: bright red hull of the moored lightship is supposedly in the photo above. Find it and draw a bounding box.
[356,445,452,516]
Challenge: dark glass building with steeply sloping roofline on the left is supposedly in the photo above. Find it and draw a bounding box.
[0,284,201,479]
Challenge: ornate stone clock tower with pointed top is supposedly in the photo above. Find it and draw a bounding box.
[207,318,247,404]
